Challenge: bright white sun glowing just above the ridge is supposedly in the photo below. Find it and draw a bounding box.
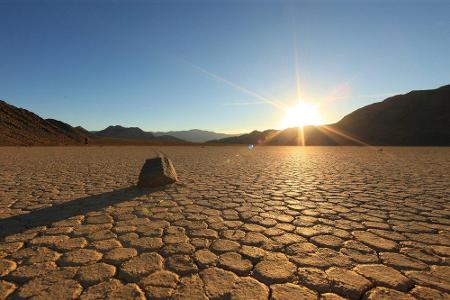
[279,101,320,129]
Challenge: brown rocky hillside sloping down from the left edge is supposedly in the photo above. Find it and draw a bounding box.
[0,100,84,146]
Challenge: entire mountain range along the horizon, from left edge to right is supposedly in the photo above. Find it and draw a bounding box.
[0,85,450,146]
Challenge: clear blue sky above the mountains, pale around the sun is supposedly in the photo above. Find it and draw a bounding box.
[0,0,450,133]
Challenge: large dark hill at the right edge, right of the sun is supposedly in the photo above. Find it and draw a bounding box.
[334,85,450,146]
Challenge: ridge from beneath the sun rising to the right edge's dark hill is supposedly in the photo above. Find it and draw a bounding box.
[210,85,450,146]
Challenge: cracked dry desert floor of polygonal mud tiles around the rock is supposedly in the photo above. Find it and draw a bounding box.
[0,146,450,299]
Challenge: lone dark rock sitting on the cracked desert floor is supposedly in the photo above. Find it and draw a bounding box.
[138,154,178,187]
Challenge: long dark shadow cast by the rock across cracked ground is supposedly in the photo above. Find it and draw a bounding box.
[0,186,165,239]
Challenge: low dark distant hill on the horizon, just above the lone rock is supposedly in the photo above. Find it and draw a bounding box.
[92,125,183,142]
